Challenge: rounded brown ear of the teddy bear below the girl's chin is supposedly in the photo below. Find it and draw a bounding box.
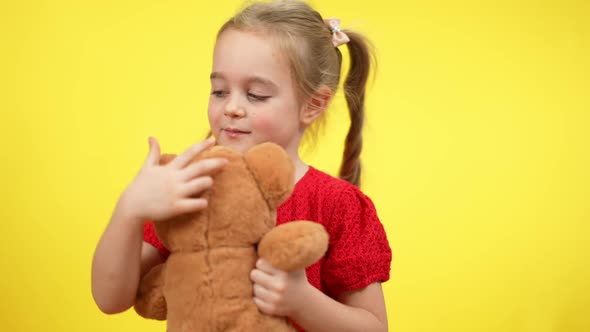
[244,143,295,209]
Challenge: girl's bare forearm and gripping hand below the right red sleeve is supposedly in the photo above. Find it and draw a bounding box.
[251,260,388,332]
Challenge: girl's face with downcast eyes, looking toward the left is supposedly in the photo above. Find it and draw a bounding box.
[209,29,303,155]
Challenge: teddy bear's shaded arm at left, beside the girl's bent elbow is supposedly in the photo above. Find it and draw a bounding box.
[133,263,166,320]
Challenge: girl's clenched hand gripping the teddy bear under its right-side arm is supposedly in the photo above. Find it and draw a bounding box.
[250,259,312,316]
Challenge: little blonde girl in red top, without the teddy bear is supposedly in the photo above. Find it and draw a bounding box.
[92,1,391,331]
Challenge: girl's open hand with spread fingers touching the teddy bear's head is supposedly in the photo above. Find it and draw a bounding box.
[121,137,227,223]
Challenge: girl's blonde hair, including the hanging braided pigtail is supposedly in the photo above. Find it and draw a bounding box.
[218,0,374,186]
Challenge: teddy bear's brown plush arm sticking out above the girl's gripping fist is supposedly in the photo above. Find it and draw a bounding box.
[258,221,328,271]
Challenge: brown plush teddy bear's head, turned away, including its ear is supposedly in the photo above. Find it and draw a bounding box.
[154,143,294,252]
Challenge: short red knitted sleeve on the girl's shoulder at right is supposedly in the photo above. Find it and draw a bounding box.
[322,187,391,296]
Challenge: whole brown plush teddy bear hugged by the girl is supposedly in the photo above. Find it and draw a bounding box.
[134,143,328,332]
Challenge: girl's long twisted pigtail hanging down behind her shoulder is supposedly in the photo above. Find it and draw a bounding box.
[339,31,373,187]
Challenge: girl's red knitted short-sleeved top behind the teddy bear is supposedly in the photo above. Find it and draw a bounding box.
[144,167,391,330]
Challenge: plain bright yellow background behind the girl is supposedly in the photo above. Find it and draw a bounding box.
[0,0,590,332]
